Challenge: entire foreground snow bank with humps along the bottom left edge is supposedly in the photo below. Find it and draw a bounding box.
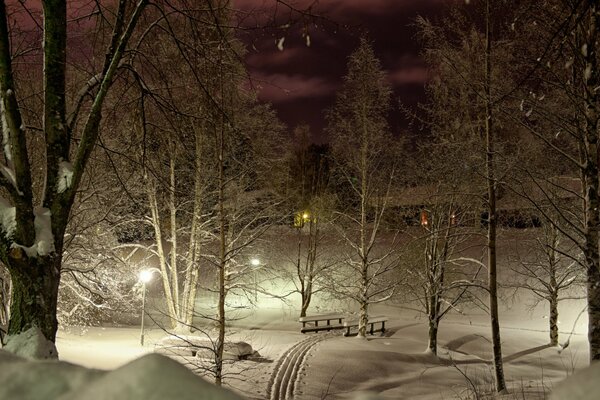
[0,350,242,400]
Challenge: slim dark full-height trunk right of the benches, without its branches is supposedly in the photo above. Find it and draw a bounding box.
[484,0,506,392]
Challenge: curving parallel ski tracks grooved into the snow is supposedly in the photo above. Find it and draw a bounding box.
[267,332,333,400]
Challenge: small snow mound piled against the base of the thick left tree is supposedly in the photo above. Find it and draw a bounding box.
[3,327,58,360]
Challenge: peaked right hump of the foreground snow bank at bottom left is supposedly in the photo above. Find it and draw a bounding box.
[61,354,242,400]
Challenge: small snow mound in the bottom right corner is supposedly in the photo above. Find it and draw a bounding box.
[550,361,600,400]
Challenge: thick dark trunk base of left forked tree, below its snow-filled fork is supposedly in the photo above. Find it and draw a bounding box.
[8,253,62,342]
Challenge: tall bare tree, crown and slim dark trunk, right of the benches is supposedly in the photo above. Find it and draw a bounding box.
[420,0,524,392]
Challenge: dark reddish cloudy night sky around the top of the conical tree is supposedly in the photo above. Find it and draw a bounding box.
[234,0,451,142]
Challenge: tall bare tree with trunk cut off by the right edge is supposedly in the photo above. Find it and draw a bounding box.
[508,0,600,360]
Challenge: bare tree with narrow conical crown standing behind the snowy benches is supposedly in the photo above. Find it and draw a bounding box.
[328,38,399,337]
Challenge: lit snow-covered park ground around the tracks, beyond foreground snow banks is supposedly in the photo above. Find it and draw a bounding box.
[50,304,588,400]
